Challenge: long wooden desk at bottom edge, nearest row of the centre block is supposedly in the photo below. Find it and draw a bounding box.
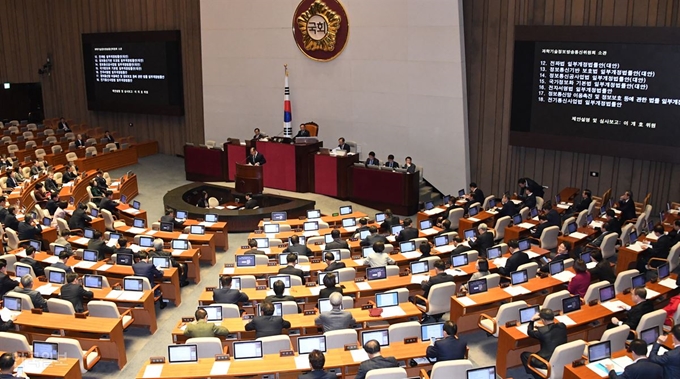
[137,342,429,379]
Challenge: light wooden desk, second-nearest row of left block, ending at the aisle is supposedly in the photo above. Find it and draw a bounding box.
[14,311,127,369]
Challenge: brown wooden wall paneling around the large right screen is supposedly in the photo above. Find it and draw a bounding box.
[463,0,680,212]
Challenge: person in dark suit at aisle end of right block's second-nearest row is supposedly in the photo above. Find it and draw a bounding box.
[520,308,567,379]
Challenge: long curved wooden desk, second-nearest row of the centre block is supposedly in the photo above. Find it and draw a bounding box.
[172,303,423,343]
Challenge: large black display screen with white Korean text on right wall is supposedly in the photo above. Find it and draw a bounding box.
[510,26,680,162]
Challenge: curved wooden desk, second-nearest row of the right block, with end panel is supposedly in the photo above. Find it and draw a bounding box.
[496,274,678,378]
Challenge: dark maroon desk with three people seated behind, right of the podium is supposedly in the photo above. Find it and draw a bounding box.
[349,166,420,215]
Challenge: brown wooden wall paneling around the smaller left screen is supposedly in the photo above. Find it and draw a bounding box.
[0,0,204,154]
